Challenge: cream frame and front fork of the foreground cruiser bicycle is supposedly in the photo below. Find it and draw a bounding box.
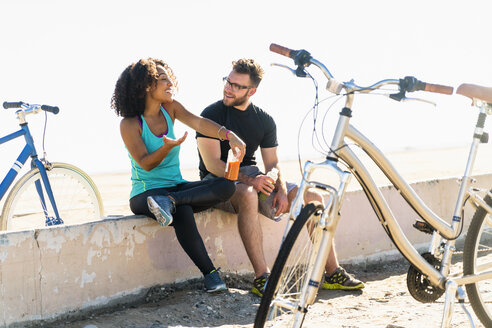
[286,94,492,305]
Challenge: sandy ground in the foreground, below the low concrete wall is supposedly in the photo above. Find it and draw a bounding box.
[45,260,483,328]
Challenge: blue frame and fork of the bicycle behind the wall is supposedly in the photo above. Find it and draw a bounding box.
[0,116,61,220]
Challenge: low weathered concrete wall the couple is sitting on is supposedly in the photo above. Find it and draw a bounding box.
[0,174,492,326]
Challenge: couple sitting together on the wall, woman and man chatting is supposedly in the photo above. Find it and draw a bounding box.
[111,58,364,297]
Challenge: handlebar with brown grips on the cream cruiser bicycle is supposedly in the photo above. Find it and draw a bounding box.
[270,43,453,96]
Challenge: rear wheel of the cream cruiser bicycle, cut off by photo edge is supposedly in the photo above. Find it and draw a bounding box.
[463,190,492,327]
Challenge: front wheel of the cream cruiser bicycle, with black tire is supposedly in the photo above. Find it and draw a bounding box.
[254,202,323,328]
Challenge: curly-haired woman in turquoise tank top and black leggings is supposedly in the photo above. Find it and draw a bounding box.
[111,58,245,292]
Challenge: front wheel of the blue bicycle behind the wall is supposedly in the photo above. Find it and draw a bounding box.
[0,163,104,230]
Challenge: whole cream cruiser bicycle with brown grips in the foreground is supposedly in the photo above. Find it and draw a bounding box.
[255,44,492,327]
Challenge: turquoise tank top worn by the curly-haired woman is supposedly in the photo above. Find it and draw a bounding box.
[128,106,187,198]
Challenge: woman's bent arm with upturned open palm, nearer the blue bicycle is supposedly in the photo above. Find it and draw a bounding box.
[120,117,187,171]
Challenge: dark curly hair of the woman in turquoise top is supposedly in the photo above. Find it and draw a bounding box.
[111,58,177,117]
